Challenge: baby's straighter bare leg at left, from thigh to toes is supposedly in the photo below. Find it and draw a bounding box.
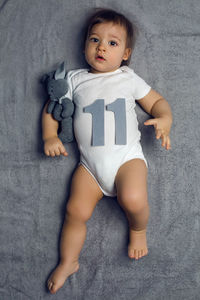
[48,166,103,294]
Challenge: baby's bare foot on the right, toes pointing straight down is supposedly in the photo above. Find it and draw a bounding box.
[128,229,148,259]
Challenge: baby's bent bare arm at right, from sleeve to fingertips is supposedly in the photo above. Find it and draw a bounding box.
[139,89,172,150]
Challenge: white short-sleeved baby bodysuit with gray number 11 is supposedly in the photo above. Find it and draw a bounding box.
[66,66,151,196]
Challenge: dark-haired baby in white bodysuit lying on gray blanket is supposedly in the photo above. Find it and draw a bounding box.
[43,9,172,294]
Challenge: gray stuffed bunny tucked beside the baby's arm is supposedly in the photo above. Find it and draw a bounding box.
[42,62,74,143]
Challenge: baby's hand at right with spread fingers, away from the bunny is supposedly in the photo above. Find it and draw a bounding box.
[144,117,172,150]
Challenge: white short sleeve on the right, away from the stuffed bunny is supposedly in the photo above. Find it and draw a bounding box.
[133,71,151,100]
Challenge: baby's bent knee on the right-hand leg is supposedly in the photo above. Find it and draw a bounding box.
[119,189,148,214]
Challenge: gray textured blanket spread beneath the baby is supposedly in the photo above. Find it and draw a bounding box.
[0,0,200,300]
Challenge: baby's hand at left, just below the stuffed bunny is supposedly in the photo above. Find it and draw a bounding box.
[44,137,68,157]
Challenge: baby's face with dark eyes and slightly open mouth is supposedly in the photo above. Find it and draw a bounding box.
[85,22,131,73]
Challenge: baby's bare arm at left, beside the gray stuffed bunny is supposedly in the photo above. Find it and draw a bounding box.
[42,102,68,157]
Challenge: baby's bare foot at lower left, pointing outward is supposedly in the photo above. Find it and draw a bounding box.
[47,262,79,294]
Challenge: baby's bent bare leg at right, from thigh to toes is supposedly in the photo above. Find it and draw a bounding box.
[116,159,149,259]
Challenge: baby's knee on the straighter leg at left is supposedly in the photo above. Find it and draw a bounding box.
[66,203,91,222]
